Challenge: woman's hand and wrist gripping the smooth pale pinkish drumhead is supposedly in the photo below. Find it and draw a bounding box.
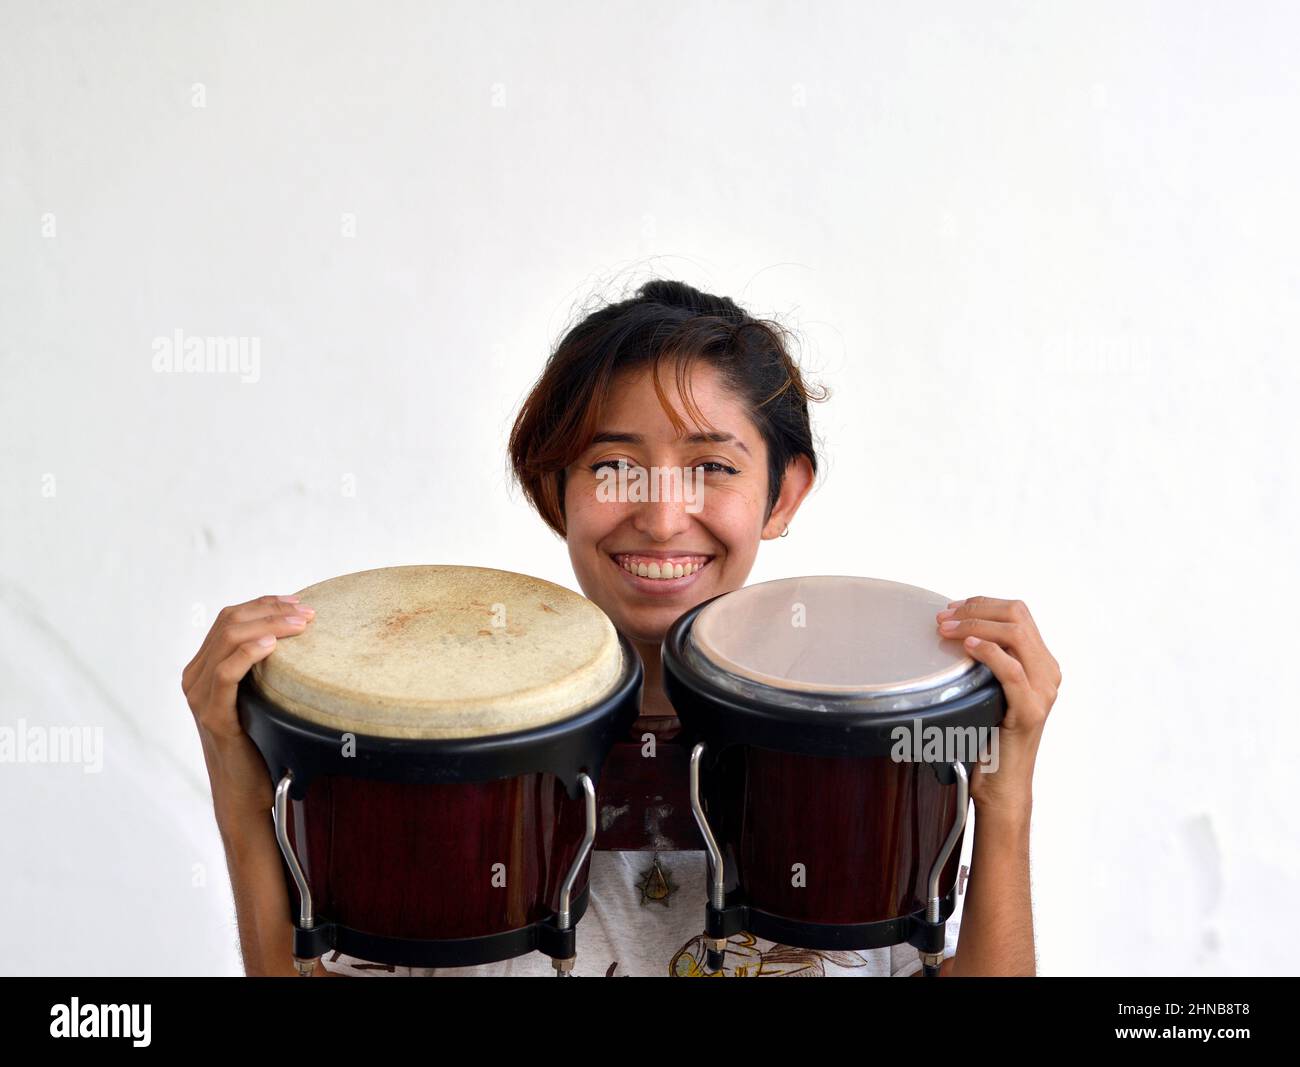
[937,597,1061,824]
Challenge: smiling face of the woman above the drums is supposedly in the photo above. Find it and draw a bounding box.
[564,361,811,643]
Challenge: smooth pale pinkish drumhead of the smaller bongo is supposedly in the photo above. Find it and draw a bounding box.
[690,576,976,695]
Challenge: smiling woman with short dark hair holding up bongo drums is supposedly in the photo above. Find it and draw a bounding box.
[182,281,1061,976]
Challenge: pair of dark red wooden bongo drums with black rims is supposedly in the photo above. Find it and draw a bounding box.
[238,565,1004,976]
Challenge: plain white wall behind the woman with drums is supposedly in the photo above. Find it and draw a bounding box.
[0,0,1300,975]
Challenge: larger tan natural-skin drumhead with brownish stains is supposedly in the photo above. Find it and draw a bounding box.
[254,565,623,738]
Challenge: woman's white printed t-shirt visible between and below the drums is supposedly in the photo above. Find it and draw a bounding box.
[321,850,965,977]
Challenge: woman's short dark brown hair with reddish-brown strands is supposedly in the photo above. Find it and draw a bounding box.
[510,279,829,537]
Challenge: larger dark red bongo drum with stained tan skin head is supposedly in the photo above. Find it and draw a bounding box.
[238,567,642,975]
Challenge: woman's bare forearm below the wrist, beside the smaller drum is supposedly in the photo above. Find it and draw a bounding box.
[943,806,1036,977]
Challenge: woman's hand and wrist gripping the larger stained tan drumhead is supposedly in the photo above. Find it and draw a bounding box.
[181,597,316,833]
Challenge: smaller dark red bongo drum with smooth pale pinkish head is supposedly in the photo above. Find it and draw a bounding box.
[663,577,1005,975]
